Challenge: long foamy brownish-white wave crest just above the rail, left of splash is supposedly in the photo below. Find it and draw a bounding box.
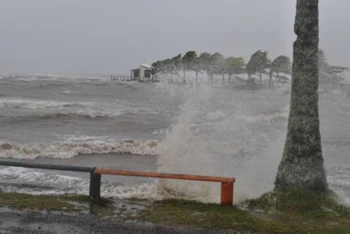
[0,139,158,159]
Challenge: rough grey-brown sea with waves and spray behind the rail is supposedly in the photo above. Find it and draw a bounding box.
[0,74,350,204]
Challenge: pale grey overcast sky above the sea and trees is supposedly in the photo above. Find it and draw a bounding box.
[0,0,350,74]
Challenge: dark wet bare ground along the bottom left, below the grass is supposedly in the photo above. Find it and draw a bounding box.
[0,208,243,234]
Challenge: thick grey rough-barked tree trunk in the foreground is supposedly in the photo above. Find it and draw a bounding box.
[275,0,328,193]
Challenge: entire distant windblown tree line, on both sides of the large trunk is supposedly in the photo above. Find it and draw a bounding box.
[152,49,347,87]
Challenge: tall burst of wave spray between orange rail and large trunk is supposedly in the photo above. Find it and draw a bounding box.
[157,86,289,202]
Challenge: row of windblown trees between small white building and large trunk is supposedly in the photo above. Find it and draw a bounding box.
[152,50,291,86]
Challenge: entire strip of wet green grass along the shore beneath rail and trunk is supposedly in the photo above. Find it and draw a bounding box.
[0,192,350,234]
